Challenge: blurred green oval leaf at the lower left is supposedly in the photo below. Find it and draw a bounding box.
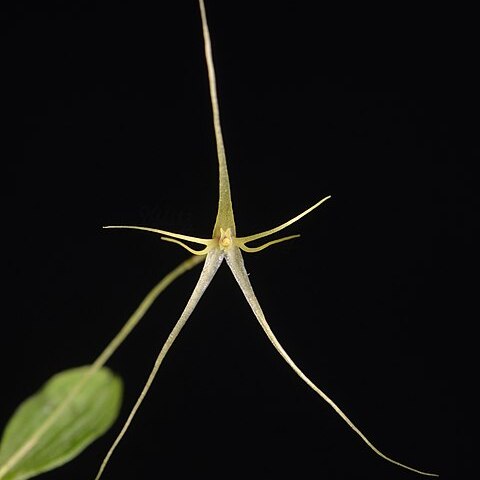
[0,366,123,480]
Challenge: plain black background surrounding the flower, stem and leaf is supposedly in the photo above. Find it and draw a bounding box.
[0,1,479,479]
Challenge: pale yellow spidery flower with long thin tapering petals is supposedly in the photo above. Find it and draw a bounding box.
[95,0,438,480]
